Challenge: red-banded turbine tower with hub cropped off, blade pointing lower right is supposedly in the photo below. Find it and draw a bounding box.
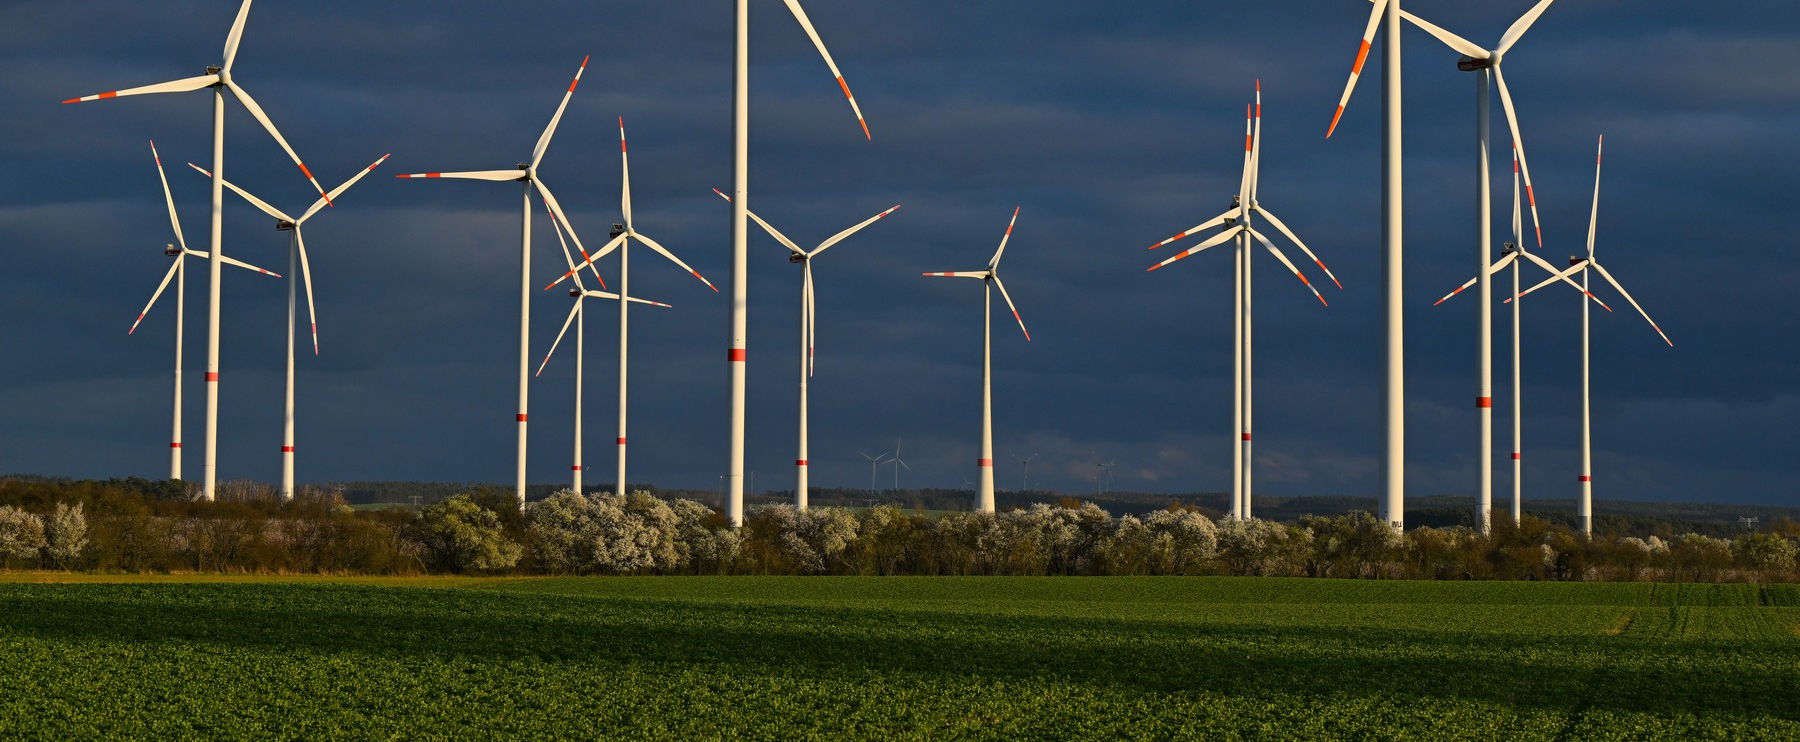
[725,0,873,526]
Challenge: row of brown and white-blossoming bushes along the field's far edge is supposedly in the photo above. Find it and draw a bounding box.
[0,479,1800,582]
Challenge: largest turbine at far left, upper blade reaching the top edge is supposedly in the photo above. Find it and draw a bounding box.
[63,0,329,501]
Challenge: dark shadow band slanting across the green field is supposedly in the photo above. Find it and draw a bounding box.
[0,585,1800,719]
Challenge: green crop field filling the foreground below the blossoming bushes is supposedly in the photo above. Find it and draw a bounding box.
[0,575,1800,740]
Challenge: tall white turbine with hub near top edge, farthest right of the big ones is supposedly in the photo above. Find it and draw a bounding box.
[1402,0,1555,533]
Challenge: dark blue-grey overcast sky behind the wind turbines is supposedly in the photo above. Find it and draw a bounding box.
[0,0,1800,508]
